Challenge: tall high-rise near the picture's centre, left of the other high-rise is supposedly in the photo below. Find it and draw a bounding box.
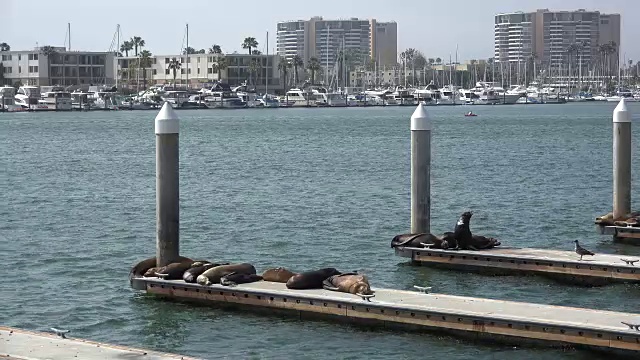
[277,17,398,72]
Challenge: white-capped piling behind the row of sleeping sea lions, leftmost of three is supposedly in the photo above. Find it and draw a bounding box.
[155,102,180,266]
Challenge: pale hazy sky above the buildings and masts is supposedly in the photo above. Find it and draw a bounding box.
[0,0,640,61]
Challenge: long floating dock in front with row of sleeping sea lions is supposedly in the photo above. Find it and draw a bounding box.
[131,277,640,356]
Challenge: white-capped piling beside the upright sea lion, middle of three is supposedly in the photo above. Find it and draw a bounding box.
[411,103,431,234]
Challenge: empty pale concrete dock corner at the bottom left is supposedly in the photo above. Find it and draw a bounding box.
[0,326,196,360]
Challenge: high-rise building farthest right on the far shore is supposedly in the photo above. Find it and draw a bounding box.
[494,9,620,68]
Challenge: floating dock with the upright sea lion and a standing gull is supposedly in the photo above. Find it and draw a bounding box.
[395,247,640,285]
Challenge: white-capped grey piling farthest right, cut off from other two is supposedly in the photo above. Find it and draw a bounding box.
[613,99,631,220]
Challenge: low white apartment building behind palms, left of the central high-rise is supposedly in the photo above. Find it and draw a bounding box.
[117,53,283,92]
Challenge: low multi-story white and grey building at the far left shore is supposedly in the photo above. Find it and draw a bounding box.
[0,47,115,86]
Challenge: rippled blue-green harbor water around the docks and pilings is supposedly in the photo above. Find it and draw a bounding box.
[0,103,640,359]
